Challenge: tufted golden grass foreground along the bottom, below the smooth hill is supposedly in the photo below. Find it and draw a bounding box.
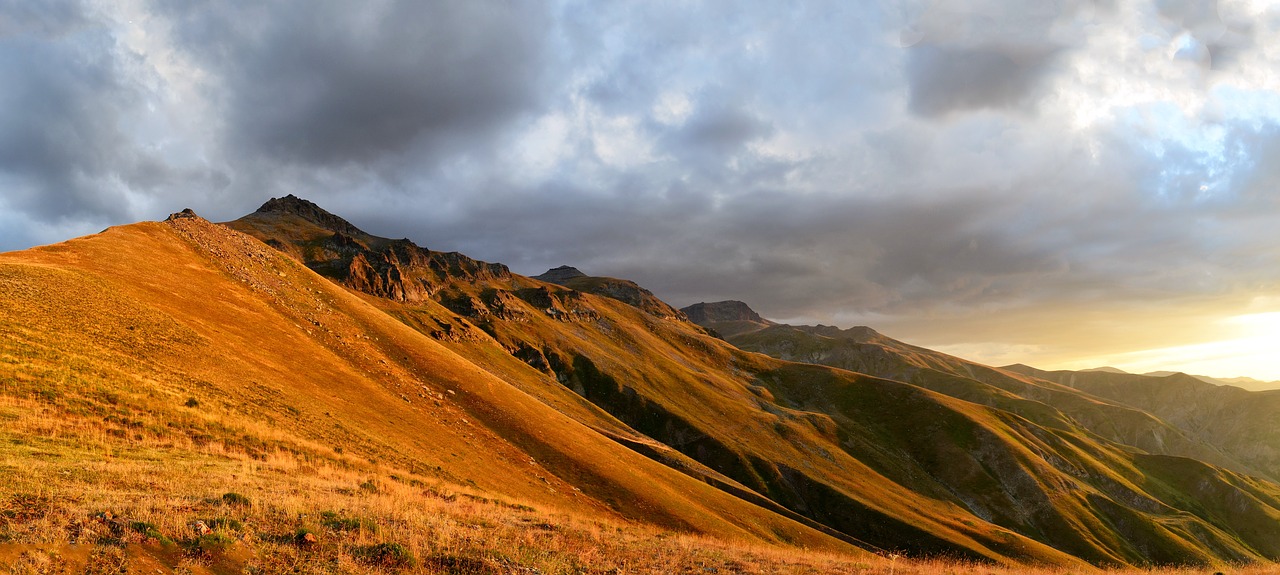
[0,396,1270,575]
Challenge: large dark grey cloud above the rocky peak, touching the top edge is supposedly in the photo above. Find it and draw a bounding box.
[154,0,550,165]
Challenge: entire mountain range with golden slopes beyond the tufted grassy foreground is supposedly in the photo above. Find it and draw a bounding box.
[0,196,1280,566]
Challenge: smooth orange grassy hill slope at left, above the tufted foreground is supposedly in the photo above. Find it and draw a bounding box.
[0,219,865,568]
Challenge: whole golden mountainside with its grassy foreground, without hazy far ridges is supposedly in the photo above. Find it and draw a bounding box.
[0,196,1280,572]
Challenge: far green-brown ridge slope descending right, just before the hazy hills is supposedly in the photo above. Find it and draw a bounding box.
[685,302,1275,563]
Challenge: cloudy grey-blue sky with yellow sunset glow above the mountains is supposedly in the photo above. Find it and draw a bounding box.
[0,0,1280,379]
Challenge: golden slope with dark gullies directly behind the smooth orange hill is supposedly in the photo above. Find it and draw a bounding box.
[232,207,1090,563]
